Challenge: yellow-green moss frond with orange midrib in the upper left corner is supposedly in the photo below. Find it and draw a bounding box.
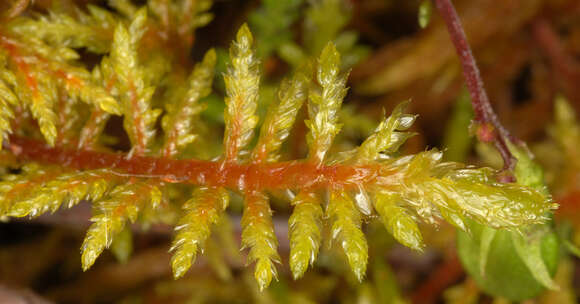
[0,10,120,144]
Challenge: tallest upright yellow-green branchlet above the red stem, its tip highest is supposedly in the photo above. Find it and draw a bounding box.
[224,24,260,160]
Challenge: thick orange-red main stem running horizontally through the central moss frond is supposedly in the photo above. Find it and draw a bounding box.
[7,136,386,191]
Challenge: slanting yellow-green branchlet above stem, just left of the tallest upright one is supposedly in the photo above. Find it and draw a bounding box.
[162,49,216,156]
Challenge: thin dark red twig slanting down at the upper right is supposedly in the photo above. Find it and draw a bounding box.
[433,0,518,170]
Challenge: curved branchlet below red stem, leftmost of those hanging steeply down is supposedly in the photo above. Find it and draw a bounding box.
[81,182,162,270]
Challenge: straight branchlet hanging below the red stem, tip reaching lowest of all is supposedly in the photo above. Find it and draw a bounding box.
[241,192,280,290]
